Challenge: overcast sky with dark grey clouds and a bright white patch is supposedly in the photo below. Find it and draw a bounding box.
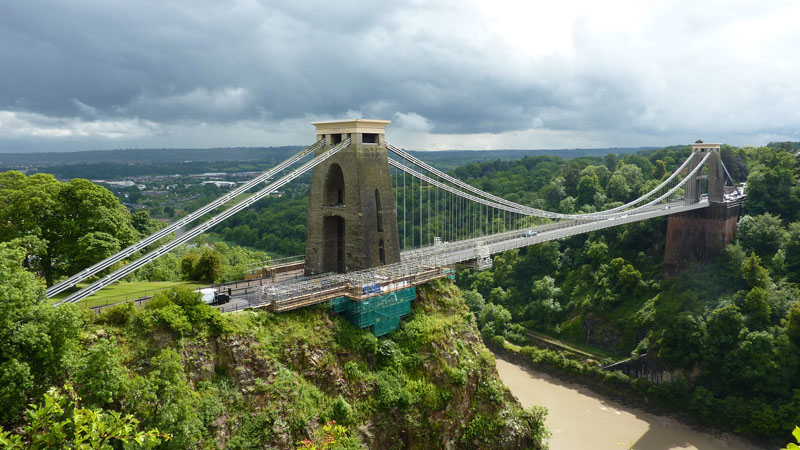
[0,0,800,152]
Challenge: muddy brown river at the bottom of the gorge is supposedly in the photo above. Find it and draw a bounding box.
[495,356,760,450]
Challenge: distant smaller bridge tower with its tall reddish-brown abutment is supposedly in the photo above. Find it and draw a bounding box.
[664,141,742,273]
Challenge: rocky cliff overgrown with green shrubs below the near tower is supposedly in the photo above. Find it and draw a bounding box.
[181,282,545,449]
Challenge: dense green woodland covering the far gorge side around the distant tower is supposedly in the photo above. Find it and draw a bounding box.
[455,146,800,436]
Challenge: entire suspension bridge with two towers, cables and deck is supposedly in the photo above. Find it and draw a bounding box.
[51,119,745,335]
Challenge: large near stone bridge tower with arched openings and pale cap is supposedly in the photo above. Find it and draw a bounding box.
[305,119,400,275]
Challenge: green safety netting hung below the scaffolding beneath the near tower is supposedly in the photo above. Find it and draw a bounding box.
[331,287,417,336]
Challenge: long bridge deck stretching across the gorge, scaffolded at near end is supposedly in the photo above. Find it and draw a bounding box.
[225,199,709,312]
